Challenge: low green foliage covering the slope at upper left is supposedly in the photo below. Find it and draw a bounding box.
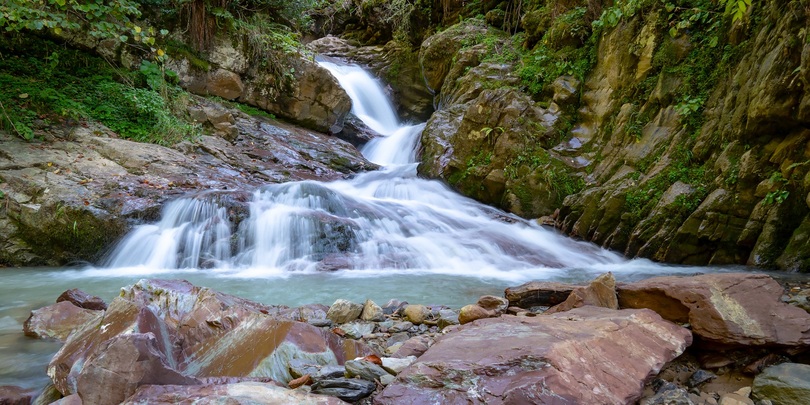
[0,36,199,144]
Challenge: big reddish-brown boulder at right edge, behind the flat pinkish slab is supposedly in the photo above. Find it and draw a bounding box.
[619,273,810,346]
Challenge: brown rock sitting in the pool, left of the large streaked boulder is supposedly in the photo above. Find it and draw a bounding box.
[23,301,103,341]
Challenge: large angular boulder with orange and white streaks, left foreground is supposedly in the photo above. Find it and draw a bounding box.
[48,280,372,404]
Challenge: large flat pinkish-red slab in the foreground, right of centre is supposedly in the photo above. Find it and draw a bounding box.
[375,307,692,404]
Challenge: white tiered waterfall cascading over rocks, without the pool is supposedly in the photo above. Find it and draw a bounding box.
[106,62,624,277]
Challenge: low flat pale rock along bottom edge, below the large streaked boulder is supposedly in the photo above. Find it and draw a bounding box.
[123,382,343,405]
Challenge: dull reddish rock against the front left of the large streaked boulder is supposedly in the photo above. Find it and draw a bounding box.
[76,333,200,405]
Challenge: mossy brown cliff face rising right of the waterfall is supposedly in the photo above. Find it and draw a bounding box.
[404,1,810,271]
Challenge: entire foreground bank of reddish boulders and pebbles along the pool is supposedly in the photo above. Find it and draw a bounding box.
[0,273,810,404]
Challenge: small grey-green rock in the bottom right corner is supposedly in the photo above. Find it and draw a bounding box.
[752,363,810,405]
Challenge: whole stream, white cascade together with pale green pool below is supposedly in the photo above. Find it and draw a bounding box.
[0,62,725,388]
